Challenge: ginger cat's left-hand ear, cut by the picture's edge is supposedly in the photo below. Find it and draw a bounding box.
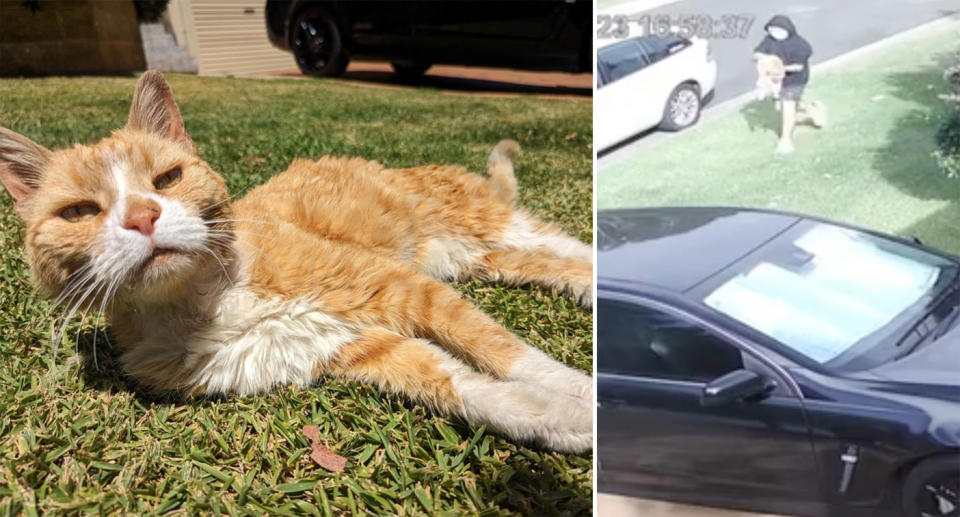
[0,127,51,219]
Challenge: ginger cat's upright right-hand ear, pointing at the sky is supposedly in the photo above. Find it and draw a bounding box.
[126,70,197,153]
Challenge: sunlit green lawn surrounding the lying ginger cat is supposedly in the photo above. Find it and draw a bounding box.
[0,75,592,515]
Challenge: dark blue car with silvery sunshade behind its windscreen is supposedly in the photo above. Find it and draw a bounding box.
[597,208,960,517]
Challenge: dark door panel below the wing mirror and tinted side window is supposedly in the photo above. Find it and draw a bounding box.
[597,374,819,511]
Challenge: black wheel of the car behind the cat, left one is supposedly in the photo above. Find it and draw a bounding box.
[290,7,349,77]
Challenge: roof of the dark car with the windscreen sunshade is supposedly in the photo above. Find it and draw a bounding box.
[597,207,804,294]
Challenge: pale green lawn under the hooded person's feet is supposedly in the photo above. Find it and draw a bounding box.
[597,22,960,252]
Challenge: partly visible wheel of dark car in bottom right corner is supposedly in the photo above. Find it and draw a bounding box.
[901,456,960,517]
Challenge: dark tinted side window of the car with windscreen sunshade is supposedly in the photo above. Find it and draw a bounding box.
[597,299,743,382]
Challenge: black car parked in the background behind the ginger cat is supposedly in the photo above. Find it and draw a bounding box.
[265,0,593,77]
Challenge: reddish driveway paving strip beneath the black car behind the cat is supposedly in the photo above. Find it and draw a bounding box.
[255,61,593,100]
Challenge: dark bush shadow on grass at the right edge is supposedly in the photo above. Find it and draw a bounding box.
[873,47,960,252]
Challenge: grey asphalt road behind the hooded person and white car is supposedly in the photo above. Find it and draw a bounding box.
[604,0,960,104]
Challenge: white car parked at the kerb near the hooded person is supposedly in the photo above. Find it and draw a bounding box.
[593,35,717,149]
